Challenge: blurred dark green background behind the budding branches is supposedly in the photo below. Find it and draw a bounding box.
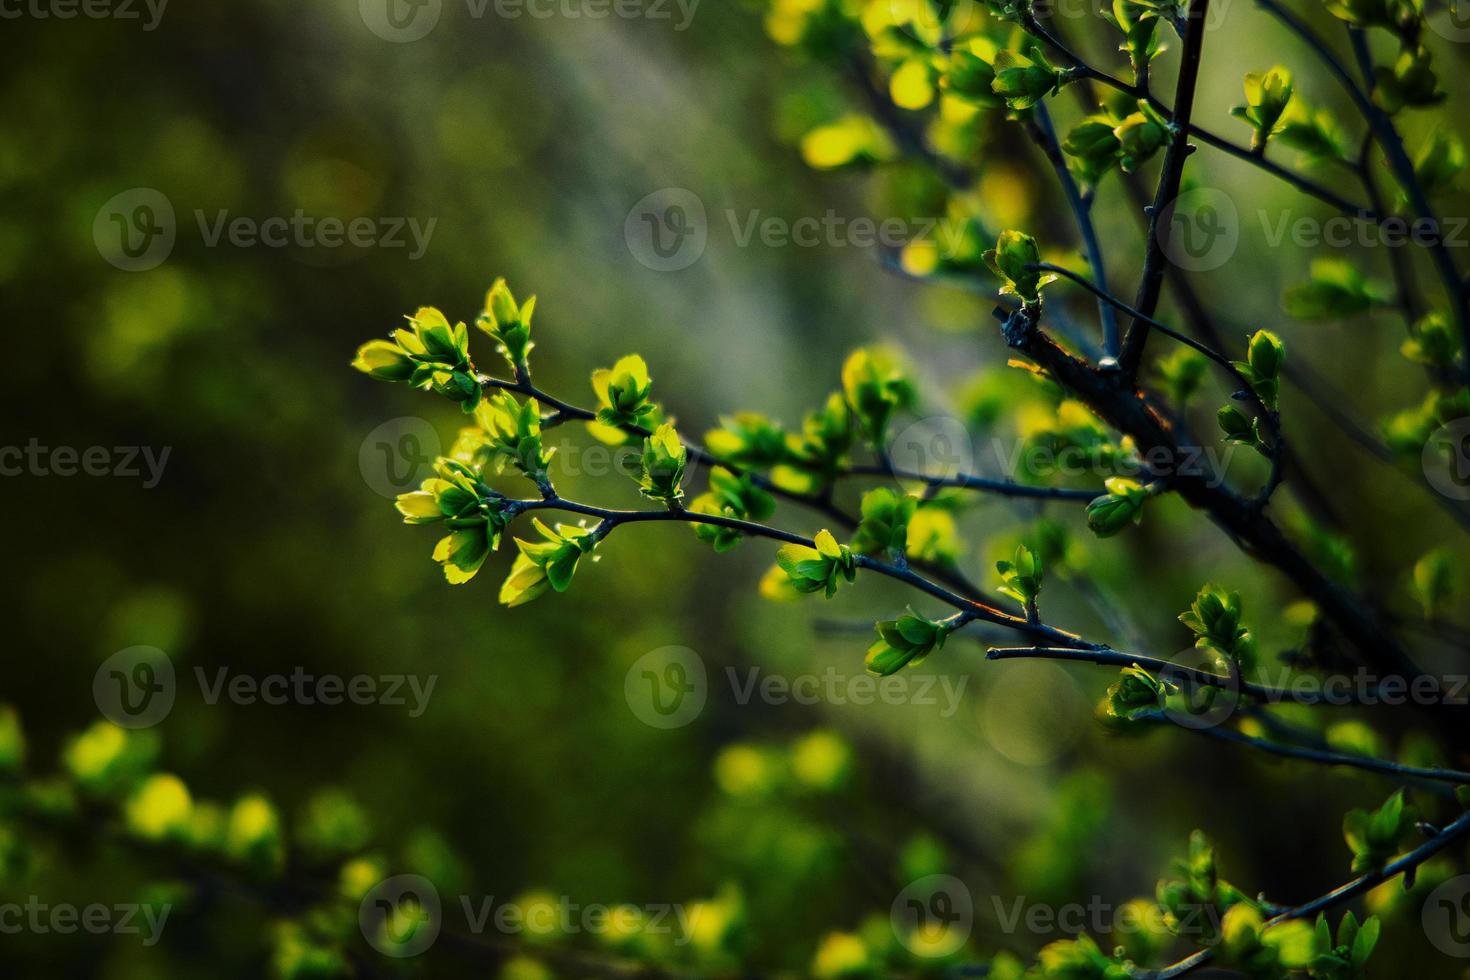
[0,0,1466,977]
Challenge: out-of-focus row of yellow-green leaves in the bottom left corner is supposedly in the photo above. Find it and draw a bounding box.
[0,705,463,980]
